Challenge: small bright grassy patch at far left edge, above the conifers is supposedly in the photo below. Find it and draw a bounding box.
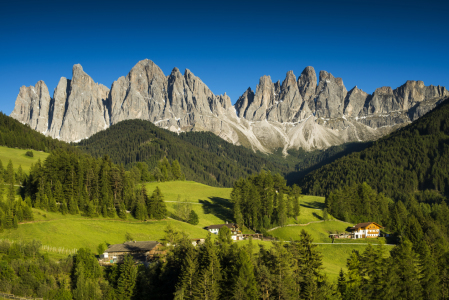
[0,146,49,173]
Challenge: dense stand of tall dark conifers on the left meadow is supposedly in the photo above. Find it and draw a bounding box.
[21,150,175,220]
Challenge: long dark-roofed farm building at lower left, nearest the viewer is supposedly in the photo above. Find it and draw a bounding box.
[100,241,165,263]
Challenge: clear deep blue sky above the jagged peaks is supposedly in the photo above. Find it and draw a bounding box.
[0,0,449,115]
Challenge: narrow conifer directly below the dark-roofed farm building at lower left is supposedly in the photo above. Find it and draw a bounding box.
[117,255,137,300]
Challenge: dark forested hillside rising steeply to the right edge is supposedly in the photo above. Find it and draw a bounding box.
[299,100,449,197]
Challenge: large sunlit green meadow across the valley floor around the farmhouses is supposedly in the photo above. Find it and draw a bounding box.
[0,181,390,280]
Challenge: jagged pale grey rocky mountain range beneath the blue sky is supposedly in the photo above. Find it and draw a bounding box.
[11,59,449,154]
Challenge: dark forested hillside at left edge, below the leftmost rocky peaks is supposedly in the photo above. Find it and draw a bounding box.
[0,112,71,152]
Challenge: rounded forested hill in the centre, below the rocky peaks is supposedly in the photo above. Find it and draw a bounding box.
[78,120,291,187]
